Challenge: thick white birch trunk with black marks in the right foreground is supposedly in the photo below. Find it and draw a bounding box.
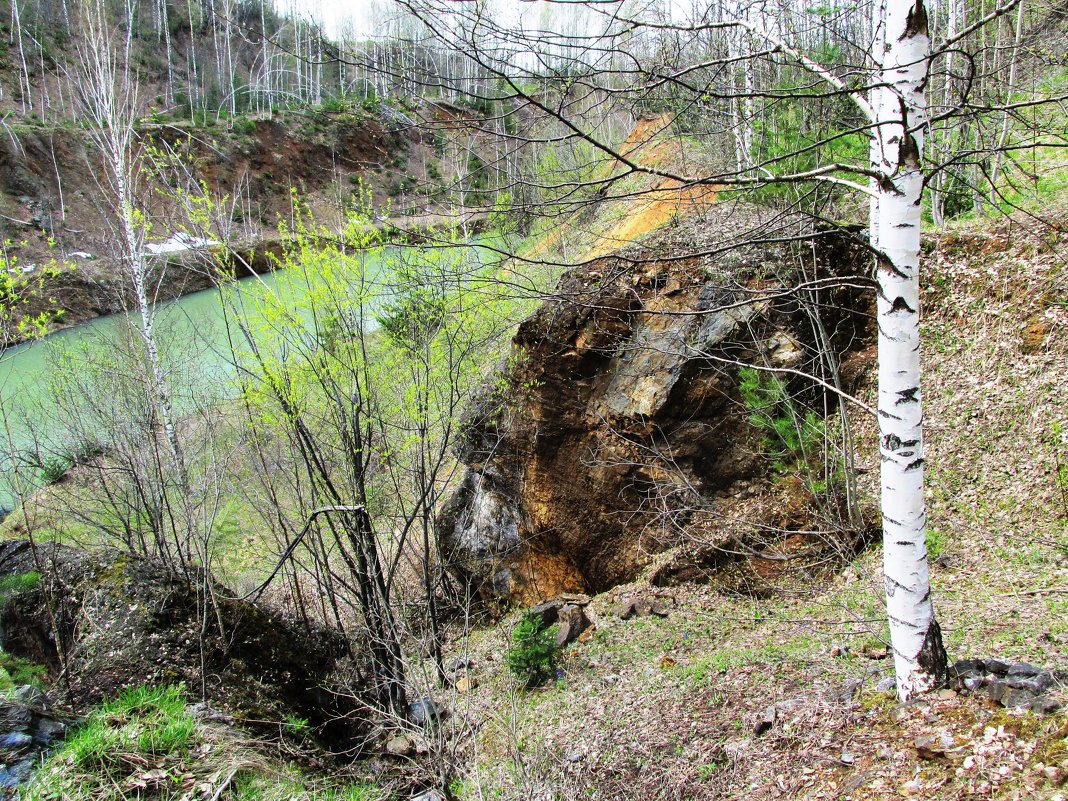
[875,0,946,701]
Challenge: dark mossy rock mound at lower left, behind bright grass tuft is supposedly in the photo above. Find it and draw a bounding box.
[0,540,363,744]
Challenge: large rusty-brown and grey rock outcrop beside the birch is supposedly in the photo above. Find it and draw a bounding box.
[439,221,873,603]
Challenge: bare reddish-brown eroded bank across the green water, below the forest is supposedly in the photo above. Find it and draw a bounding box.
[0,98,499,343]
